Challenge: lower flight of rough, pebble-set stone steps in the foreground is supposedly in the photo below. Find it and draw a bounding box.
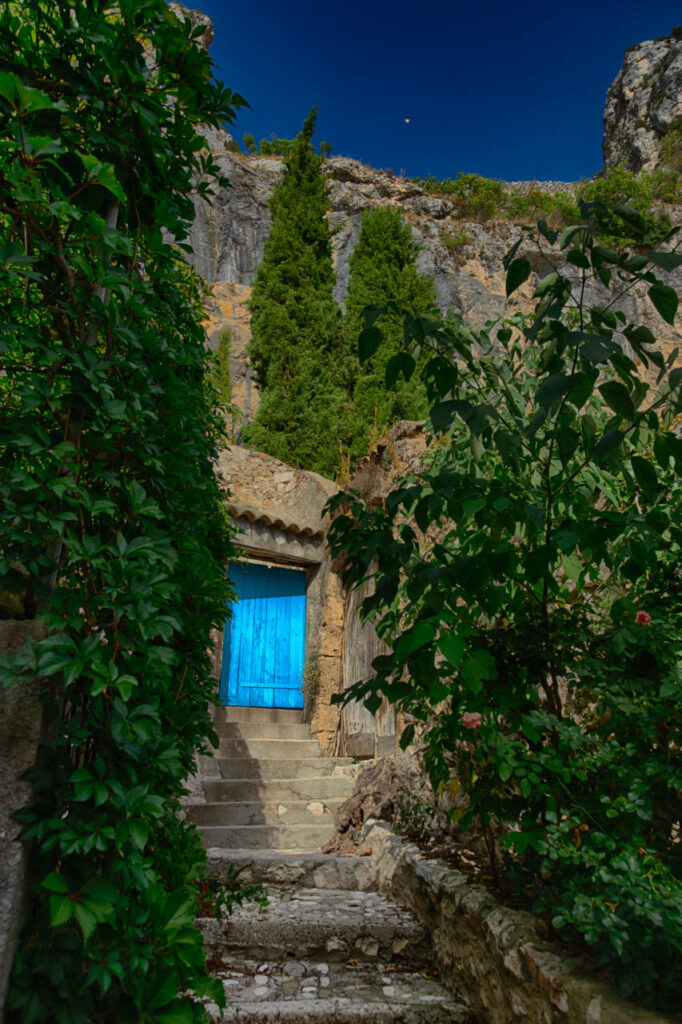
[199,850,474,1024]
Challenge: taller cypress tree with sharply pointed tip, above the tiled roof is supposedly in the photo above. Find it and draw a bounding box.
[244,110,347,476]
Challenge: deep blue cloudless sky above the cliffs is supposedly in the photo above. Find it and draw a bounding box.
[196,0,682,180]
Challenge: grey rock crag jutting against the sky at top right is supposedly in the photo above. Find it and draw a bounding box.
[603,32,682,172]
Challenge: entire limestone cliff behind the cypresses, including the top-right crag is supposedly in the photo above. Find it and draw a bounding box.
[190,12,682,432]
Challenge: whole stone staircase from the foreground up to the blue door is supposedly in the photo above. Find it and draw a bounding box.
[186,708,473,1024]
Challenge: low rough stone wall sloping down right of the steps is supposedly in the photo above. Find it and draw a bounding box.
[360,821,669,1024]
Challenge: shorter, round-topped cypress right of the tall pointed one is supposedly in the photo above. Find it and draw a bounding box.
[344,207,435,462]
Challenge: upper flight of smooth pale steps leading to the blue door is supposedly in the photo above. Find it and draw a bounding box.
[186,708,352,851]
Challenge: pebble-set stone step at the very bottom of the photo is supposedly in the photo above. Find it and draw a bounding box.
[201,956,474,1024]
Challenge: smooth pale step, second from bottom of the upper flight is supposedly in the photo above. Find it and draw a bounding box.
[186,797,343,826]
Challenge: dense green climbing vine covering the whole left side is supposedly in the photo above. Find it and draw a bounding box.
[0,0,244,1024]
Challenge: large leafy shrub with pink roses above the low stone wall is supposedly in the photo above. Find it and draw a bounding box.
[330,203,682,1007]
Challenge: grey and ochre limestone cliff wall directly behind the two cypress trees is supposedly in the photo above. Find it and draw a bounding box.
[191,140,682,422]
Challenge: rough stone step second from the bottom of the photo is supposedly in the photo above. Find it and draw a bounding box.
[201,888,431,964]
